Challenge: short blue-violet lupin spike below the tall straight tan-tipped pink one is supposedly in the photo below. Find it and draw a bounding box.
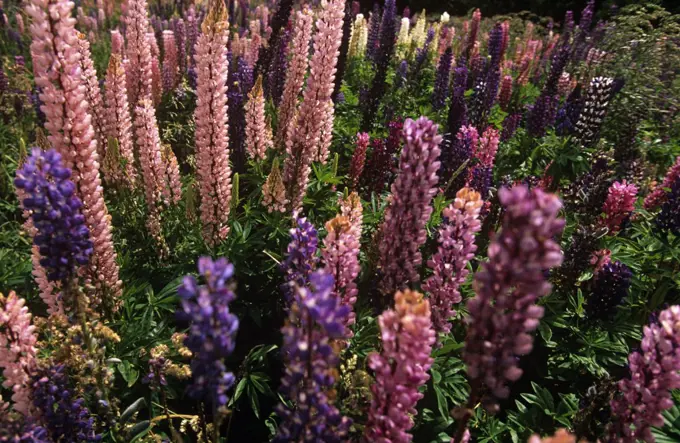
[177,257,238,408]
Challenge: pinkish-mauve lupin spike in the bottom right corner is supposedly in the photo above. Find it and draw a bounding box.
[609,306,680,443]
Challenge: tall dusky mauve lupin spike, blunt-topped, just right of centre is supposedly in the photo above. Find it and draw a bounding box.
[378,117,442,295]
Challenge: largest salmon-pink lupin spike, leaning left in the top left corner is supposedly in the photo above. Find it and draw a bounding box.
[26,0,122,306]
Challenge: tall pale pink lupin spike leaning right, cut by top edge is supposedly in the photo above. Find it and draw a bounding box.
[283,0,345,211]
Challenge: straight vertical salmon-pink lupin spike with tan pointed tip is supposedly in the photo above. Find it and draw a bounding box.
[194,2,232,245]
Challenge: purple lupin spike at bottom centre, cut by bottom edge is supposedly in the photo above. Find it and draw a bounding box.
[274,271,351,443]
